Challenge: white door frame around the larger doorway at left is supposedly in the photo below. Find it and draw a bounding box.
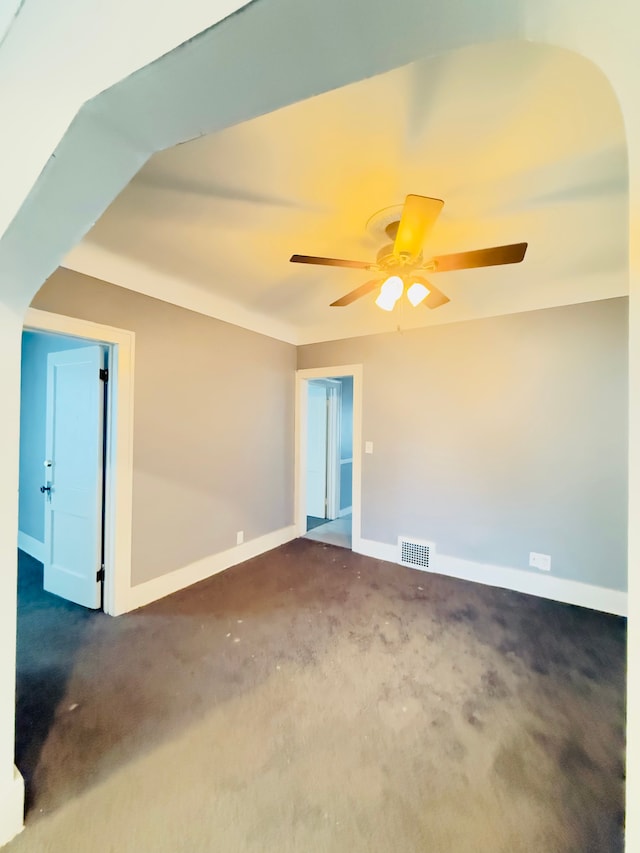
[24,308,135,616]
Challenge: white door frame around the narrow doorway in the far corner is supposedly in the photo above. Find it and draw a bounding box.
[294,364,362,551]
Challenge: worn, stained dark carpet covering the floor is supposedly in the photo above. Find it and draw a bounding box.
[7,539,625,853]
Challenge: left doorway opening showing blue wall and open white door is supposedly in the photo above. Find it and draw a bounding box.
[18,330,110,610]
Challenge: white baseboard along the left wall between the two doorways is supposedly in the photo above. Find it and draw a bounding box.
[126,525,297,613]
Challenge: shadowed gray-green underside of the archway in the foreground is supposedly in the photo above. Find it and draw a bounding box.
[0,0,628,310]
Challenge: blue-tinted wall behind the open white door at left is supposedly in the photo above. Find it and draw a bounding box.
[18,332,87,542]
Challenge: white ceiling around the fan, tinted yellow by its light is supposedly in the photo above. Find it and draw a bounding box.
[65,42,627,343]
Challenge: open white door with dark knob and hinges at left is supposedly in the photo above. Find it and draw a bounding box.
[43,346,105,609]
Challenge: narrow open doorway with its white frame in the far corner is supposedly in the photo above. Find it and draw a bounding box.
[296,365,362,548]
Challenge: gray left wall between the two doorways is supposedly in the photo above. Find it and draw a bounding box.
[33,269,296,584]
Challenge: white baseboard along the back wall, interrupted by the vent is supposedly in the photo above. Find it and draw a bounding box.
[352,539,627,616]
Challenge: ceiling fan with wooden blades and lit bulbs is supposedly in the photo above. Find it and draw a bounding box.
[289,195,528,311]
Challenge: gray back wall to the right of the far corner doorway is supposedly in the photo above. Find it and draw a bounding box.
[298,298,627,590]
